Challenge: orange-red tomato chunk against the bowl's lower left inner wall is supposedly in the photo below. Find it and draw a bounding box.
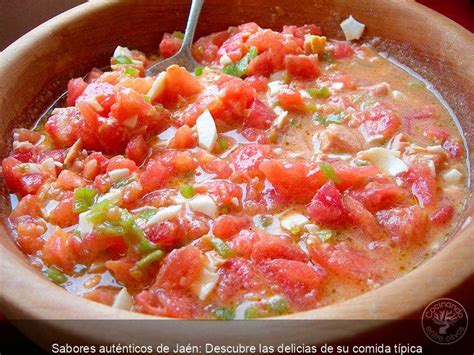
[15,216,47,255]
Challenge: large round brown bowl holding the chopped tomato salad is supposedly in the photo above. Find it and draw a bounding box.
[0,0,474,350]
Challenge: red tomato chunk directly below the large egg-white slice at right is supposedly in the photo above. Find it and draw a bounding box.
[350,182,405,212]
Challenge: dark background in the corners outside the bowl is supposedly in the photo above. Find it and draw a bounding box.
[0,0,474,355]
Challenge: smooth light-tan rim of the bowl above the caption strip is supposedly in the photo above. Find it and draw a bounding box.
[0,0,474,340]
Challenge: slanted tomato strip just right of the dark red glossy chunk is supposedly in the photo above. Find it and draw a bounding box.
[343,196,385,240]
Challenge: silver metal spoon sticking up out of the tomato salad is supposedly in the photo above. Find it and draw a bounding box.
[145,0,204,76]
